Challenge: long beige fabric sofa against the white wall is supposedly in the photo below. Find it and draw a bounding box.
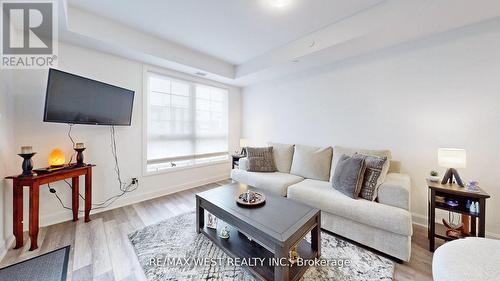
[231,144,413,261]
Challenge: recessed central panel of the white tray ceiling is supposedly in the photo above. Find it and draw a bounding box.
[64,0,383,65]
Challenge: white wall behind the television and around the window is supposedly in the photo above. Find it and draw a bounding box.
[1,43,240,235]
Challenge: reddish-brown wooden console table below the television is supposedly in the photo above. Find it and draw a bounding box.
[6,164,95,251]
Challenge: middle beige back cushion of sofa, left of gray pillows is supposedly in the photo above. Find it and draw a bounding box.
[290,145,332,181]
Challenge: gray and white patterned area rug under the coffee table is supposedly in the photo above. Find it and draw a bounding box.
[129,213,394,281]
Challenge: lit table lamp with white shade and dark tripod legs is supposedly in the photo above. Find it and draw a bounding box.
[438,148,467,187]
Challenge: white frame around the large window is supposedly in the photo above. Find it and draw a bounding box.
[142,66,231,176]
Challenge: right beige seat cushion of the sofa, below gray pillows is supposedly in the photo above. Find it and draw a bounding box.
[287,179,412,235]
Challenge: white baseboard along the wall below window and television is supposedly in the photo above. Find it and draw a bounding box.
[37,173,229,227]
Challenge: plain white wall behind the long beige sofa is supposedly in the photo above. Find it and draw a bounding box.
[242,18,500,237]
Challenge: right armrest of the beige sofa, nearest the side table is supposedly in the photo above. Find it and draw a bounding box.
[378,173,411,211]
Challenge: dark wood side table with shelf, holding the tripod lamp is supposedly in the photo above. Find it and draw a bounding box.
[427,180,490,252]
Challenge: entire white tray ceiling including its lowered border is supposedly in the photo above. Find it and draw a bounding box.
[59,0,500,86]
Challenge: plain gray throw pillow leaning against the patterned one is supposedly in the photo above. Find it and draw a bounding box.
[332,154,365,199]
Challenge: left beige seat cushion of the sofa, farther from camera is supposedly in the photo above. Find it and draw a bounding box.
[231,169,304,196]
